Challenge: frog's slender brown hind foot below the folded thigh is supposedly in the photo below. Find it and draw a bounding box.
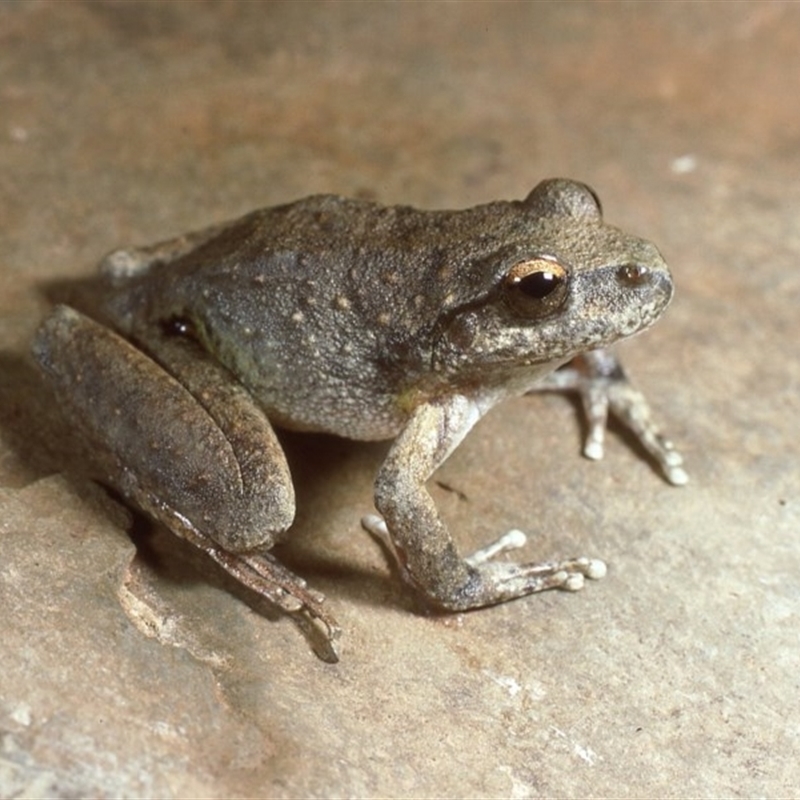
[186,531,342,663]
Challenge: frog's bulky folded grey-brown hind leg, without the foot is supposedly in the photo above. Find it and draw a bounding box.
[34,307,294,551]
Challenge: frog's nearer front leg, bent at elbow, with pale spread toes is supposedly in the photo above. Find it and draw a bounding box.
[363,395,605,610]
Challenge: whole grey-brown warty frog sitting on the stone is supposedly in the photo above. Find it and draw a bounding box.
[33,178,687,661]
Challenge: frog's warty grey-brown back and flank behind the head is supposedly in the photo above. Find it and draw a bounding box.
[103,195,536,438]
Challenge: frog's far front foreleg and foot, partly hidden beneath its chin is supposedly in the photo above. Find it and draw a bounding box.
[532,350,689,486]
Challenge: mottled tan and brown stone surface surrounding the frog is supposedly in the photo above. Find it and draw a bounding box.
[0,0,800,798]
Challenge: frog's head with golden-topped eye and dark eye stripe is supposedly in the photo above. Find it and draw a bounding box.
[434,179,673,380]
